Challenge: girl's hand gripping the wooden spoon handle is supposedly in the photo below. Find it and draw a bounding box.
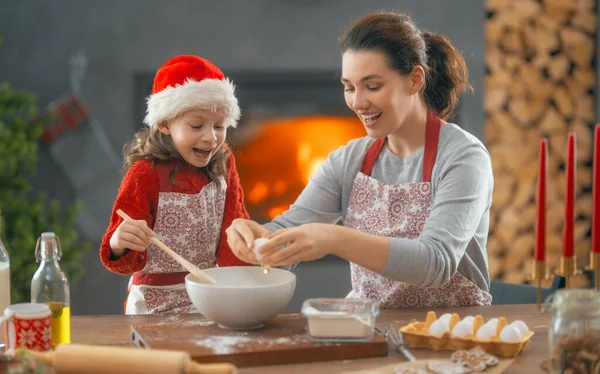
[109,219,154,257]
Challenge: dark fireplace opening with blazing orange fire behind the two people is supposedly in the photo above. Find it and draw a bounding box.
[135,72,365,223]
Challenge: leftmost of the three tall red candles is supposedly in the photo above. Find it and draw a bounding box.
[535,138,548,261]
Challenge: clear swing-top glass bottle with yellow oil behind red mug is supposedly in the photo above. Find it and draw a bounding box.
[31,232,71,347]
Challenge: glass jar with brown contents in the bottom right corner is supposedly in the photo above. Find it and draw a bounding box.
[548,289,600,373]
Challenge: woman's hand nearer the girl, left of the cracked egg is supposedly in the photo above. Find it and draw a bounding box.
[225,218,271,265]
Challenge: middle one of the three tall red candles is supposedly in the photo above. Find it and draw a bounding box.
[563,132,577,257]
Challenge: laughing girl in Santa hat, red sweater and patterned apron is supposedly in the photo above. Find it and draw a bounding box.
[100,56,248,314]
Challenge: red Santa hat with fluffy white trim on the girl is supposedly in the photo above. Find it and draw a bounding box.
[144,56,240,128]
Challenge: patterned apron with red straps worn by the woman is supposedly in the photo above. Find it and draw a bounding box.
[344,112,492,308]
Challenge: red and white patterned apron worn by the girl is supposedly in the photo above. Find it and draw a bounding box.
[125,164,227,314]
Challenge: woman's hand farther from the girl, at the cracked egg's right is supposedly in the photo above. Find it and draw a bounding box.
[259,223,336,266]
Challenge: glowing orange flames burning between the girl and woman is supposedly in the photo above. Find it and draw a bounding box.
[236,117,365,221]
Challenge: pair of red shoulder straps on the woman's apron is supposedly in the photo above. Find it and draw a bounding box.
[360,111,441,182]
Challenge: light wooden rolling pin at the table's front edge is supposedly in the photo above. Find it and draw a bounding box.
[29,344,237,374]
